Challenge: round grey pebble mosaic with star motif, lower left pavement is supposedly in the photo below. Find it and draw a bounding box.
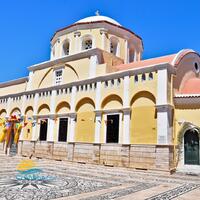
[0,172,116,200]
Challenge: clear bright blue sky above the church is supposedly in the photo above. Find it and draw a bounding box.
[0,0,200,82]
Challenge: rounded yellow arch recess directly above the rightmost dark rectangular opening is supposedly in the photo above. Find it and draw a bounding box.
[101,94,123,109]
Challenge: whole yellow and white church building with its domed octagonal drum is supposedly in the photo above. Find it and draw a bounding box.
[0,16,200,171]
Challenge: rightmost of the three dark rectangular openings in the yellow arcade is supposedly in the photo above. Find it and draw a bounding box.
[106,114,119,143]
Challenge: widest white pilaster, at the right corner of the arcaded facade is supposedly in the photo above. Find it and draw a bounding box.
[156,69,172,144]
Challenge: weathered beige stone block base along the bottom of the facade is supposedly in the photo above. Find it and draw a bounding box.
[18,141,175,171]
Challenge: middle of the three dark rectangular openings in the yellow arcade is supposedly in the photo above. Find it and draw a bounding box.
[58,118,68,142]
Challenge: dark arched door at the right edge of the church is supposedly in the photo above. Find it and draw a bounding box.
[184,130,199,165]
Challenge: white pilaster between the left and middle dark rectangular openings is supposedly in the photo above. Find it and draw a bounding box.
[47,90,56,142]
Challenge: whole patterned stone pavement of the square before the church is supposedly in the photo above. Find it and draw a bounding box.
[0,153,200,200]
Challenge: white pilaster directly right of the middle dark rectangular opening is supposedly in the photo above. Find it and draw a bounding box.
[68,86,77,142]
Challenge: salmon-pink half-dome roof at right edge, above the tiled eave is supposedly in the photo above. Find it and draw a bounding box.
[181,78,200,94]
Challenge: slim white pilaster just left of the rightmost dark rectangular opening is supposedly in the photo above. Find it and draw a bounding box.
[95,81,102,143]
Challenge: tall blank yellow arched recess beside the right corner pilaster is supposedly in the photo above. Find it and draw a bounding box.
[130,91,157,144]
